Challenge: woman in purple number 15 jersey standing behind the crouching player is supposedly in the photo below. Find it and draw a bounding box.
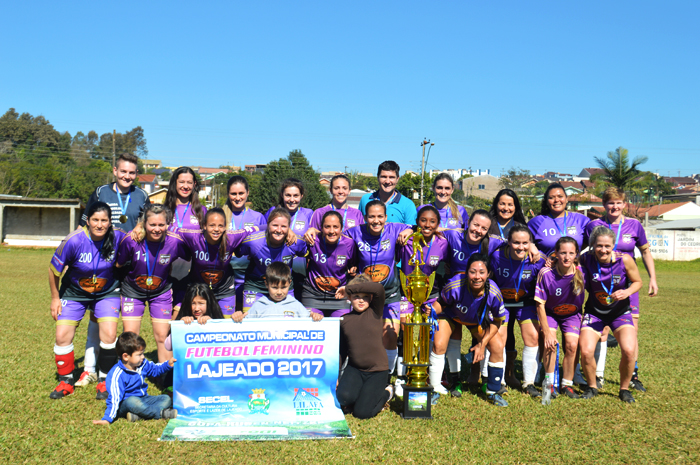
[490,224,544,397]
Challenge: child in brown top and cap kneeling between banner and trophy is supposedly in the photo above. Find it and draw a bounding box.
[336,275,393,419]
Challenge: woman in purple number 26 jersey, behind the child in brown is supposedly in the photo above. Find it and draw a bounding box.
[347,200,411,380]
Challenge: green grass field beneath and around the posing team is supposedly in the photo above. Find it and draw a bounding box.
[0,247,700,464]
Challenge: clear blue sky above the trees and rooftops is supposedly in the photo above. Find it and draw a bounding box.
[0,1,700,176]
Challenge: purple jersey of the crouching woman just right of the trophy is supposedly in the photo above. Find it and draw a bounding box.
[440,276,506,326]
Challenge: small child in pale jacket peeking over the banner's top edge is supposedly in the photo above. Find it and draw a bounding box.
[233,262,323,322]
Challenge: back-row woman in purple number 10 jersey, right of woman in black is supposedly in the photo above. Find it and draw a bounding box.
[527,182,590,256]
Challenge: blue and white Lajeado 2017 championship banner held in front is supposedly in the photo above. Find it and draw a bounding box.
[161,318,352,441]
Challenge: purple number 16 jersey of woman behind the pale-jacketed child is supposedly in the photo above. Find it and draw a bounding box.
[236,231,307,294]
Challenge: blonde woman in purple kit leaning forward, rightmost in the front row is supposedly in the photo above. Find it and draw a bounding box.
[581,226,642,403]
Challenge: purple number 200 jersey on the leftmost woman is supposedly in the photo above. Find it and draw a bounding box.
[50,226,126,301]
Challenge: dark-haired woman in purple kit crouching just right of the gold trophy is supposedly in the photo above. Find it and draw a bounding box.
[430,253,508,407]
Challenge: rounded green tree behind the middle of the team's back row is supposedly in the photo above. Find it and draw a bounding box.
[249,150,330,212]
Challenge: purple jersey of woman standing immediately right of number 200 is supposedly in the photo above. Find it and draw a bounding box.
[117,231,190,299]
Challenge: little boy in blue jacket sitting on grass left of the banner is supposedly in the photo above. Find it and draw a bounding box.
[92,331,177,425]
